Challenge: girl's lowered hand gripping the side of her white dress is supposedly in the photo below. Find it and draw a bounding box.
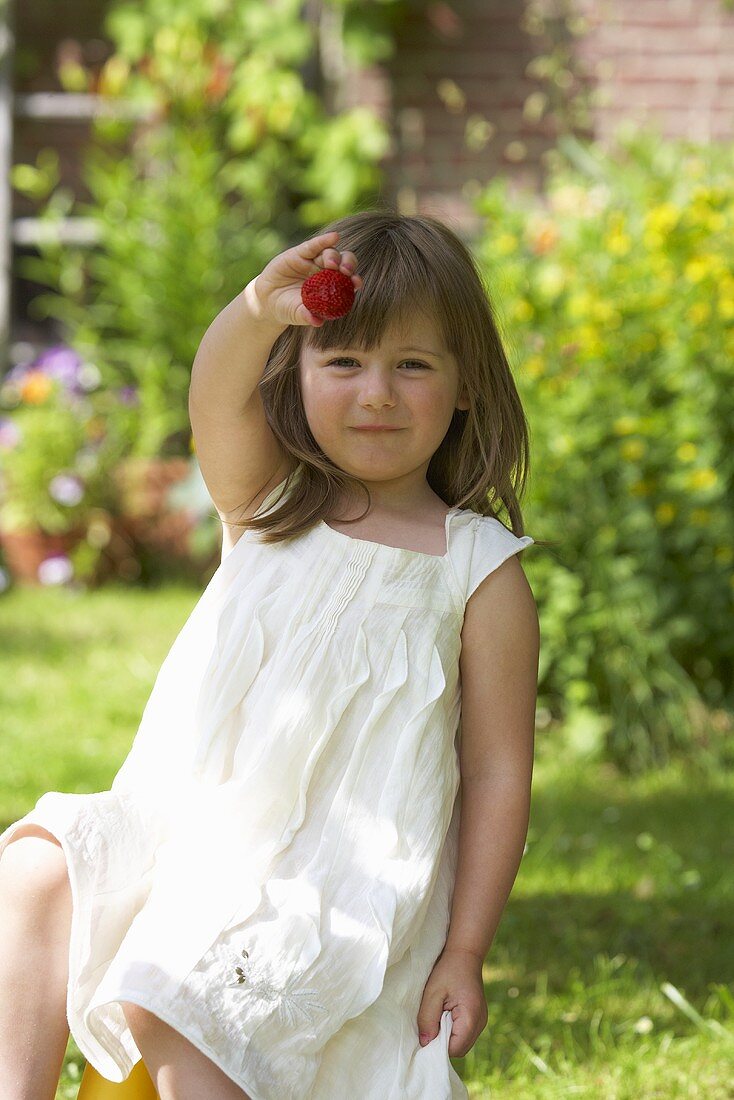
[418,948,489,1058]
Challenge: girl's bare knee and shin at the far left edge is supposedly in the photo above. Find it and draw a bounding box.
[0,825,72,1100]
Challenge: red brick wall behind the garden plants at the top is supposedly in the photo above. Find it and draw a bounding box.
[353,0,734,232]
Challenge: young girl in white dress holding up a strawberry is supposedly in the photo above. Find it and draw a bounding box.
[0,210,538,1100]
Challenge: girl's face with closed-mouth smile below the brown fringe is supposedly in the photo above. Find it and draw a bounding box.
[299,317,469,505]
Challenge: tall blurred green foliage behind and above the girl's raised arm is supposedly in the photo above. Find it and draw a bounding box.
[8,0,398,457]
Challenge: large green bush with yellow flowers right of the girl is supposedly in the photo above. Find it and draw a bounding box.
[470,126,734,769]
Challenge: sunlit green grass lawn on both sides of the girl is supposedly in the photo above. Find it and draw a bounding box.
[0,585,734,1100]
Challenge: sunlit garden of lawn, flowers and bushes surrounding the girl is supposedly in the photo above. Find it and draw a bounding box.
[0,0,734,1100]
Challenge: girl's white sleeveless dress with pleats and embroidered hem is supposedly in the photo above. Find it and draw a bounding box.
[0,466,534,1100]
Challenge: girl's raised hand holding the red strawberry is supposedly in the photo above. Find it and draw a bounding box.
[250,230,362,328]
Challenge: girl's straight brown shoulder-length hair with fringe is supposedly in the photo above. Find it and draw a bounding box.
[224,209,528,542]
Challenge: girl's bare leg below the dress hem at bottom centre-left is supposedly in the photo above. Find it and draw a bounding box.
[121,1001,254,1100]
